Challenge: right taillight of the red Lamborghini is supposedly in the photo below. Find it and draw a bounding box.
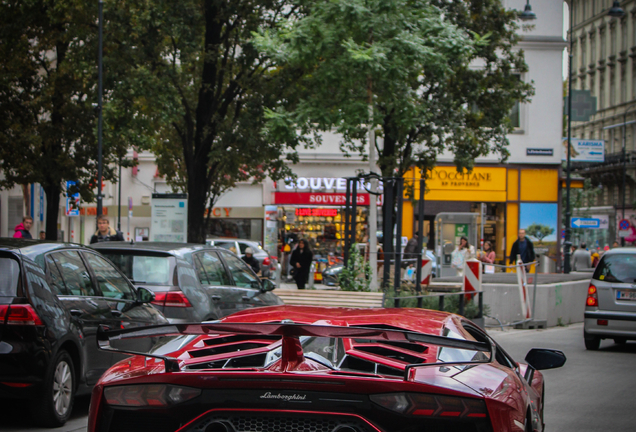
[370,393,488,418]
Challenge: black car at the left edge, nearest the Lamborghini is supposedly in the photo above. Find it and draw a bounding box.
[0,239,167,426]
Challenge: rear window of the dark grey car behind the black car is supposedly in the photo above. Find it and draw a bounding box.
[100,251,174,285]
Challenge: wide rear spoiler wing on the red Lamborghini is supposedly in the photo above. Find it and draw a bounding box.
[97,322,494,378]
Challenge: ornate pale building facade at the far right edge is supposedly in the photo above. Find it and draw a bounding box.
[568,0,636,247]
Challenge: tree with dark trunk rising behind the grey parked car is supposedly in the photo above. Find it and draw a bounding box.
[101,0,301,243]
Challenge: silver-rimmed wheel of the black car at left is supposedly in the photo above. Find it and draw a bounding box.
[33,351,75,427]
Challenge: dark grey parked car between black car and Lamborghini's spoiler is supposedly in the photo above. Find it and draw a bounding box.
[93,242,283,322]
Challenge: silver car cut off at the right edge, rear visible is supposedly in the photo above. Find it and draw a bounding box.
[583,248,636,350]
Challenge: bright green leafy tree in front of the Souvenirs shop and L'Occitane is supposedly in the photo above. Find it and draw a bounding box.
[257,0,532,181]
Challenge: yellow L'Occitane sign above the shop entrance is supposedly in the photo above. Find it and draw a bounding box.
[426,167,506,191]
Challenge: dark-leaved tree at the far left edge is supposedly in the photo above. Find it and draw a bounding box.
[0,0,130,240]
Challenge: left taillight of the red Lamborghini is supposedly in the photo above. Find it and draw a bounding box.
[104,384,201,407]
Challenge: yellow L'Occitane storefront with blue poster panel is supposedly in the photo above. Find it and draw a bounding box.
[402,165,559,261]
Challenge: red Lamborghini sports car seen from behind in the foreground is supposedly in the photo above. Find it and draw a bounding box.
[88,306,565,432]
